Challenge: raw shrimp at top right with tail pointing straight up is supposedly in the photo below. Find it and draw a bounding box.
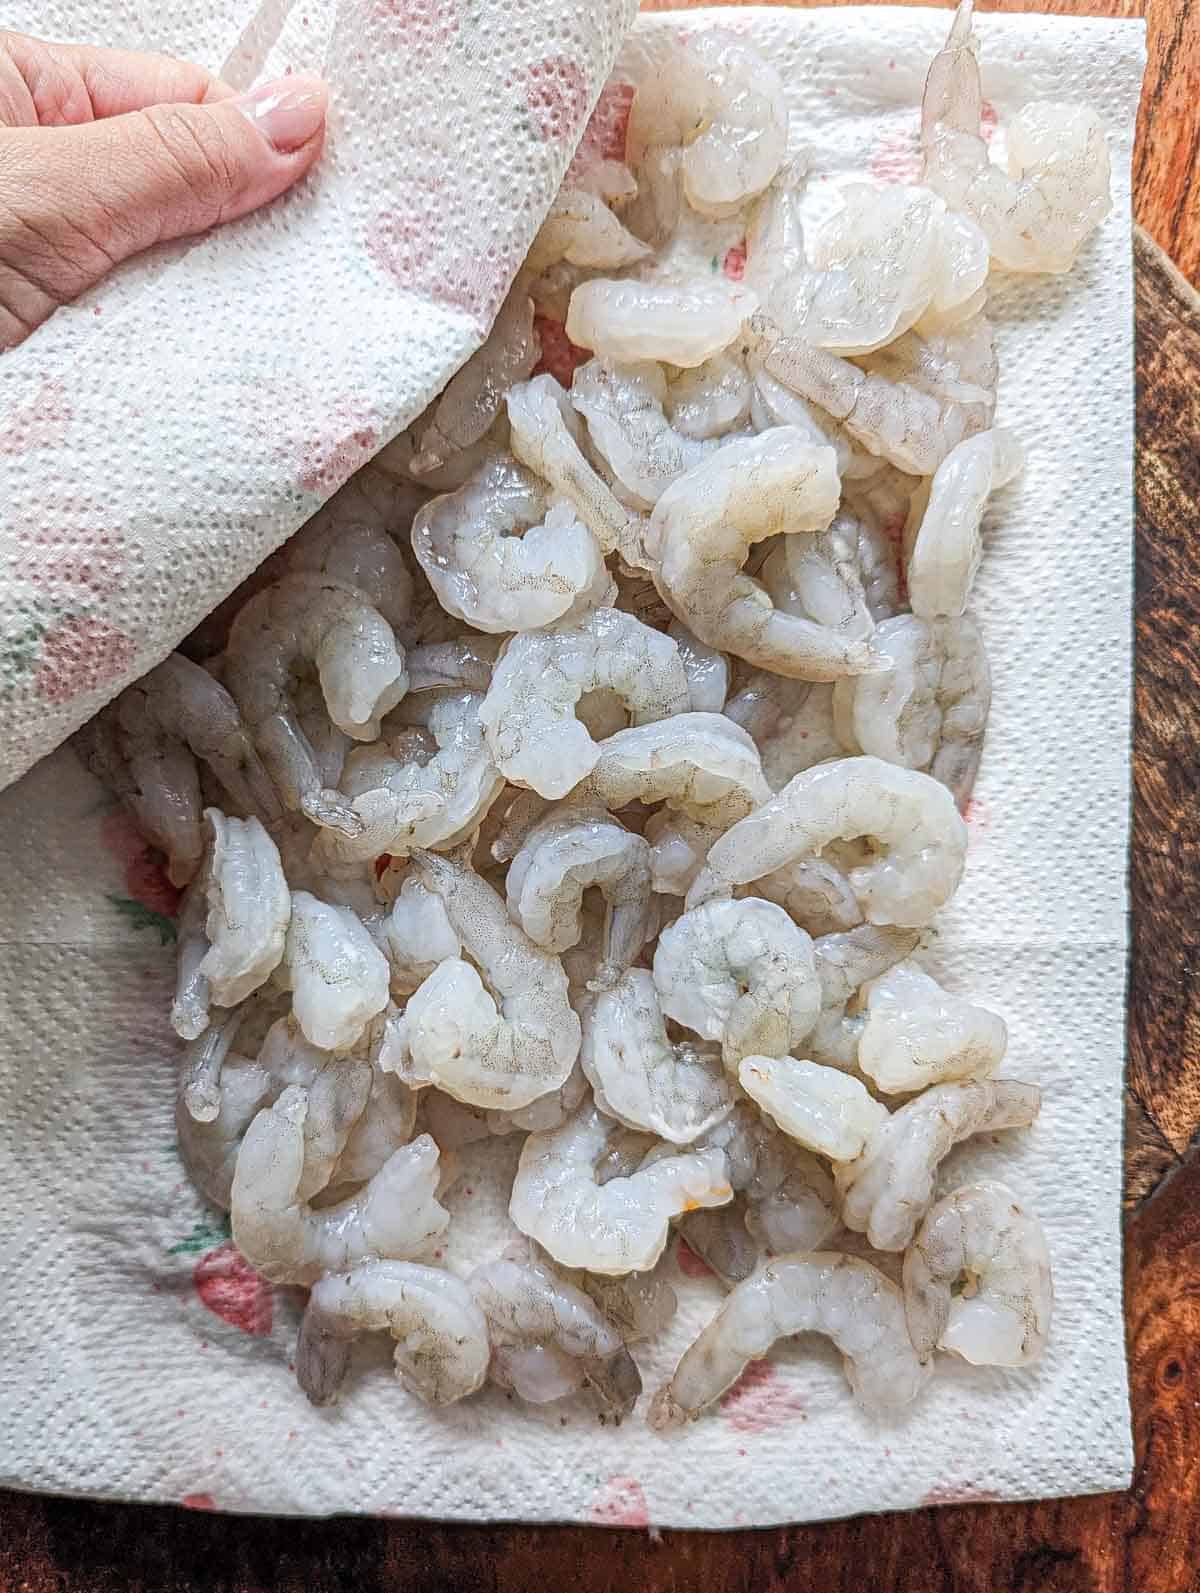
[921,0,1112,272]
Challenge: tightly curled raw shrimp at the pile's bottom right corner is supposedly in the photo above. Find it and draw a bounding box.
[904,1179,1053,1367]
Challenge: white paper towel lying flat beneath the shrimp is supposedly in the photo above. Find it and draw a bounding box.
[0,8,1143,1528]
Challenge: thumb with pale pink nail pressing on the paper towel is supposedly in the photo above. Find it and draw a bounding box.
[0,76,328,347]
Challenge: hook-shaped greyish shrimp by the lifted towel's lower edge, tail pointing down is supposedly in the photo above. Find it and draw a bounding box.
[225,575,408,835]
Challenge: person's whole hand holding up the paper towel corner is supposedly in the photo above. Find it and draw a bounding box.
[0,32,328,350]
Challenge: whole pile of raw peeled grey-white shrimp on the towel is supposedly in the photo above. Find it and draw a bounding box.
[86,0,1108,1427]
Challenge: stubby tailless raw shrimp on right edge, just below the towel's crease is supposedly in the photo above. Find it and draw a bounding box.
[859,962,1009,1094]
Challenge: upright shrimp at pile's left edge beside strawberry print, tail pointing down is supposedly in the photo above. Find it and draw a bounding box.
[171,808,292,1040]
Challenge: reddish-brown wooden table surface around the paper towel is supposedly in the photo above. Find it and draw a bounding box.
[0,0,1200,1593]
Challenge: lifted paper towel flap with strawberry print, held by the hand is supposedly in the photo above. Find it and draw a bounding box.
[0,0,636,785]
